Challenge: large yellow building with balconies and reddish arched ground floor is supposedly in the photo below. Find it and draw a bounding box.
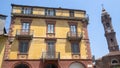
[2,4,92,68]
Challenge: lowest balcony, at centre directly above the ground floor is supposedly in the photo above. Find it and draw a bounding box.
[42,52,60,61]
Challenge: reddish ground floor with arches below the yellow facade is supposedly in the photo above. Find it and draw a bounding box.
[2,59,93,68]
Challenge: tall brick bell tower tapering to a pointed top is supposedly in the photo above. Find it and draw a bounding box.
[101,8,119,52]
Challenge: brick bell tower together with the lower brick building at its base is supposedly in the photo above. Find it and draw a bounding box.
[96,8,120,68]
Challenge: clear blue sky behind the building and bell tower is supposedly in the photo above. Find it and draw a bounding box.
[0,0,120,58]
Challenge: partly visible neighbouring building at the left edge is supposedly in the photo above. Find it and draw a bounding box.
[0,14,7,68]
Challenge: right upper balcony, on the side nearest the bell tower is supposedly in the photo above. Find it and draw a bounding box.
[67,32,83,41]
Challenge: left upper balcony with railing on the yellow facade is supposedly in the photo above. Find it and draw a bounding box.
[16,29,34,39]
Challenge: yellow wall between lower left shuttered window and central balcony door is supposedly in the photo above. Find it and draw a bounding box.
[28,39,46,59]
